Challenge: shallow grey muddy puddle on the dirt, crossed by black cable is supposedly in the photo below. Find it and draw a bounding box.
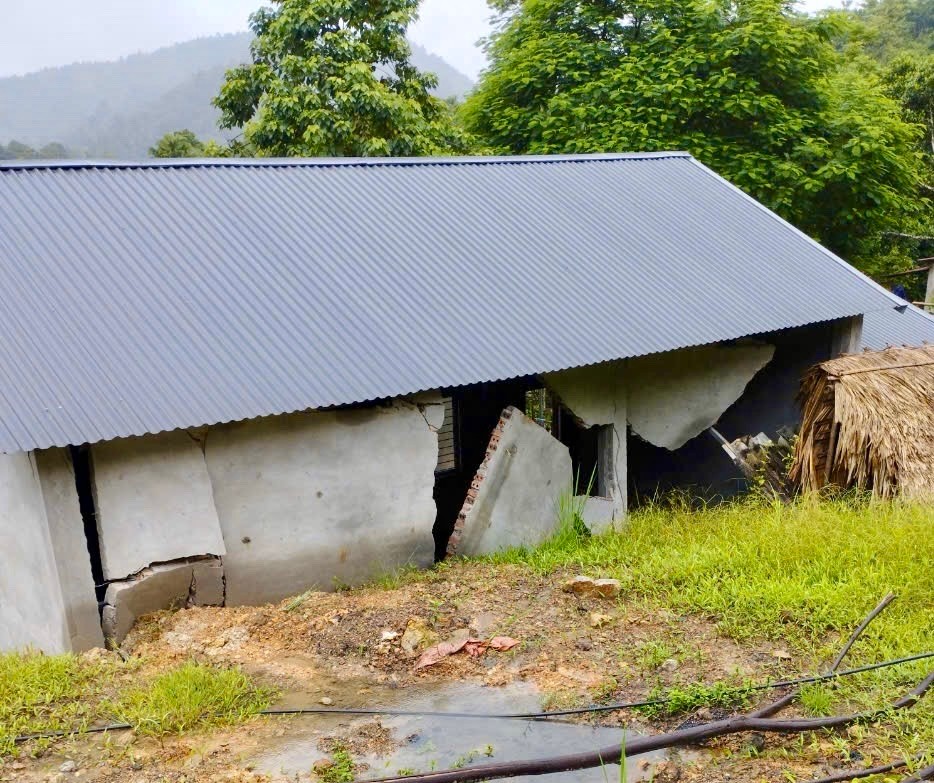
[251,683,686,783]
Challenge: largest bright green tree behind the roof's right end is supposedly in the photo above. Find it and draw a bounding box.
[463,0,918,268]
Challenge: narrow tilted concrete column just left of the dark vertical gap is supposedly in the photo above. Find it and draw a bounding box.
[35,449,104,652]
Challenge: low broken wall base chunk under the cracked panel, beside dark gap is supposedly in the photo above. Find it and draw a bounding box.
[103,558,224,644]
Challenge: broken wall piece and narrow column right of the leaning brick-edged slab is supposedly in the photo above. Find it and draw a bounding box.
[544,362,628,532]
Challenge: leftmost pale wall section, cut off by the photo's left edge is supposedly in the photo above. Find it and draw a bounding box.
[0,454,69,654]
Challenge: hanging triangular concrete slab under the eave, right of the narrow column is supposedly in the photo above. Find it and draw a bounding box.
[626,344,775,451]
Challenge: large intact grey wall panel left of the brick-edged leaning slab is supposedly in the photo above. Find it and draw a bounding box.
[205,402,438,605]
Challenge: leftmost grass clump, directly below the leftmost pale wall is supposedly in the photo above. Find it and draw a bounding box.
[0,653,116,758]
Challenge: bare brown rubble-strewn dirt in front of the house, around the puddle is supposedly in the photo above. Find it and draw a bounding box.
[0,563,887,783]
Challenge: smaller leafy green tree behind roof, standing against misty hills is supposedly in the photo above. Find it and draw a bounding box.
[215,0,465,157]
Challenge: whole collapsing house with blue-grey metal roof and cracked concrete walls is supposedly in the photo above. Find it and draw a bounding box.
[0,153,904,652]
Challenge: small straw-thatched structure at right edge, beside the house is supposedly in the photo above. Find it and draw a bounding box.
[791,346,934,499]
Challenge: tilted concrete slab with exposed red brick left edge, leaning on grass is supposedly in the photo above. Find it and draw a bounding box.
[447,408,572,557]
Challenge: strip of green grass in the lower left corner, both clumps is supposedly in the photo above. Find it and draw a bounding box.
[0,653,273,758]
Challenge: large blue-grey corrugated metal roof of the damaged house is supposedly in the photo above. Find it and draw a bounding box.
[0,153,908,451]
